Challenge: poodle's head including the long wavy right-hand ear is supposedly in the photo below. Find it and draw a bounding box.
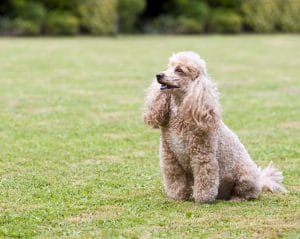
[156,52,221,131]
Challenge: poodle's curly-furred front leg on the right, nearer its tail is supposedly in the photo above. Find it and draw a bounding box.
[192,153,219,203]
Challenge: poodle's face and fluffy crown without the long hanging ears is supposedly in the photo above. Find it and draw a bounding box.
[156,51,207,93]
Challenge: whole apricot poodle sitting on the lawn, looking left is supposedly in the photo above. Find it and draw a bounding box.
[143,52,286,203]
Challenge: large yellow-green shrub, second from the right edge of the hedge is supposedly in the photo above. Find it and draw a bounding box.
[242,0,280,32]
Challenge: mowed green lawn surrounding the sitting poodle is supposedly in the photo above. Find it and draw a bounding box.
[0,35,300,238]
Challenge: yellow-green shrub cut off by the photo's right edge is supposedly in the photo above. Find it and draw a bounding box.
[278,0,300,32]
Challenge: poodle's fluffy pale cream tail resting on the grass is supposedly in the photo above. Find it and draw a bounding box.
[259,162,287,193]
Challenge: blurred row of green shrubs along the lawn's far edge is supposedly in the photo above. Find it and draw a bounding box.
[0,0,300,36]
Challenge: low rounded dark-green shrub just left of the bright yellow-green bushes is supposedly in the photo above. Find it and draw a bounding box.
[208,9,242,33]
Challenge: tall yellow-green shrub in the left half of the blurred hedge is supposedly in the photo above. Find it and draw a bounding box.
[78,0,117,35]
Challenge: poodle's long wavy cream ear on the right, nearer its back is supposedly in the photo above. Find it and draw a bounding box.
[182,74,221,131]
